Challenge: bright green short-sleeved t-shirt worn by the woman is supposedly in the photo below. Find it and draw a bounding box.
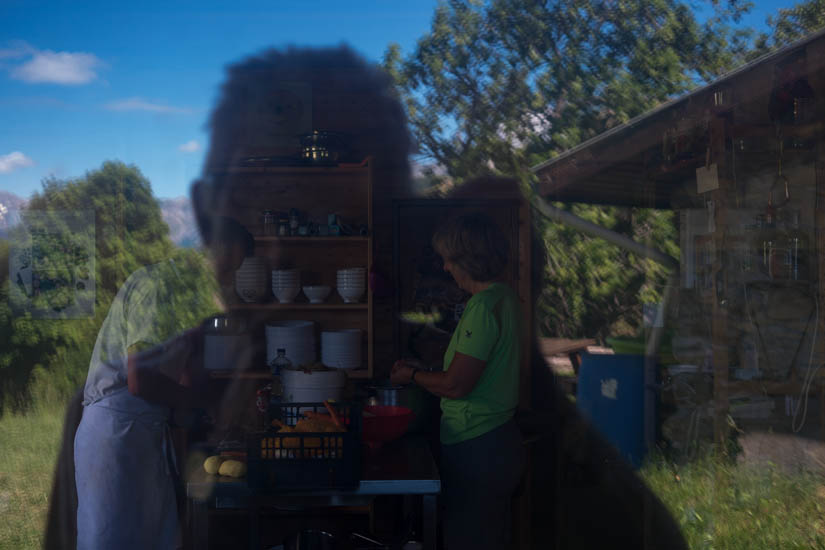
[441,283,522,445]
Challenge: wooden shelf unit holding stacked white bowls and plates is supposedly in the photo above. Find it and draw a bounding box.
[213,158,374,378]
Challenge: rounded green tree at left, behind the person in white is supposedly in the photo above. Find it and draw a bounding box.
[0,162,219,411]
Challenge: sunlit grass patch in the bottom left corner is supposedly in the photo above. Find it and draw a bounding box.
[0,406,64,550]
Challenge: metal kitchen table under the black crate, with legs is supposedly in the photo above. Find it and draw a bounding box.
[186,436,441,550]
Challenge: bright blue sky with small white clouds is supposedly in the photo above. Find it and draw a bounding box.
[0,0,793,202]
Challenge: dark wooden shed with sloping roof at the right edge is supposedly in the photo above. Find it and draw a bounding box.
[532,28,825,442]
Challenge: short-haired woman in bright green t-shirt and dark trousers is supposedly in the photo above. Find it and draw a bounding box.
[391,213,524,550]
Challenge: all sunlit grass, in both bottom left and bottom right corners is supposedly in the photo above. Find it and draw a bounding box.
[0,406,825,550]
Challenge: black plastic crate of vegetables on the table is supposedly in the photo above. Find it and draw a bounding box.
[246,402,361,492]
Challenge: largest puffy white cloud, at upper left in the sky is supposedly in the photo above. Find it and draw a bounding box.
[8,50,103,85]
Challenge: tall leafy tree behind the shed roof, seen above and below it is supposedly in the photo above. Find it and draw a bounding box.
[384,0,751,336]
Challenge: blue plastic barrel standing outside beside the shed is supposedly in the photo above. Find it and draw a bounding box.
[576,354,645,468]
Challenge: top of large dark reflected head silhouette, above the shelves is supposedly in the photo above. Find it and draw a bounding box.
[191,46,411,258]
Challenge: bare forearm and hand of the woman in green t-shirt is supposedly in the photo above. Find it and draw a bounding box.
[391,351,487,399]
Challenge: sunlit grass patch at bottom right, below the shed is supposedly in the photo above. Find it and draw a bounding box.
[642,457,825,550]
